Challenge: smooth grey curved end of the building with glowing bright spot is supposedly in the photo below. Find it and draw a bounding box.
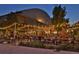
[18,8,51,24]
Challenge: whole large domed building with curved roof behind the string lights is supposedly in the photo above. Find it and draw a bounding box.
[0,8,51,27]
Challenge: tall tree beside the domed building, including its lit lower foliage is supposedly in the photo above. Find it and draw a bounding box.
[51,5,69,31]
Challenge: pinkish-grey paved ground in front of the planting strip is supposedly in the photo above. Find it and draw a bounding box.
[0,44,79,54]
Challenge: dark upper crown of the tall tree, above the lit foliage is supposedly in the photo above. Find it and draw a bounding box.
[51,5,69,25]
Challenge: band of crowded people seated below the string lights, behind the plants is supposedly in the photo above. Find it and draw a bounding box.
[0,32,79,45]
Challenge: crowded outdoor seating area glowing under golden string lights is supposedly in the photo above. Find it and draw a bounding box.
[0,23,79,51]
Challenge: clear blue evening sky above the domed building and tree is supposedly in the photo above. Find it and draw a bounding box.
[0,4,79,23]
